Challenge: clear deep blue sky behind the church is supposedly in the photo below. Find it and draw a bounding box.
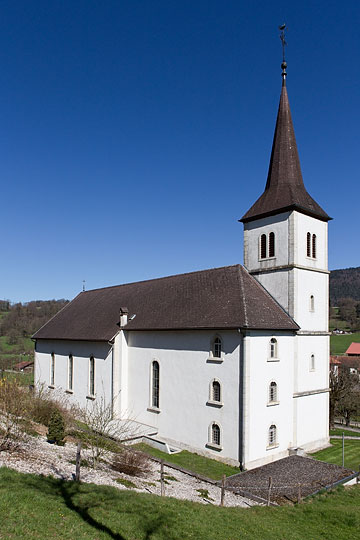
[0,0,360,301]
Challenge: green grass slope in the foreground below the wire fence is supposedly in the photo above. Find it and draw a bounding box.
[0,468,360,540]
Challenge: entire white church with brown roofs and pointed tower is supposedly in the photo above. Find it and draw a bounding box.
[33,58,331,469]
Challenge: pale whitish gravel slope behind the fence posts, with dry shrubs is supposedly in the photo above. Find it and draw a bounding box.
[0,436,256,508]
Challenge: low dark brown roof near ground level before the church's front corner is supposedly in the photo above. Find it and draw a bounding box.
[226,456,354,504]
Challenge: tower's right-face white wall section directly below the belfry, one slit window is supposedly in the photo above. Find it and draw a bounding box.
[293,268,329,332]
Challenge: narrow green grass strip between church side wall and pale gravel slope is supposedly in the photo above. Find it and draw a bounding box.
[136,443,240,480]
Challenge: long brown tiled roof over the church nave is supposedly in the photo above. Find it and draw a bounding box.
[33,265,299,341]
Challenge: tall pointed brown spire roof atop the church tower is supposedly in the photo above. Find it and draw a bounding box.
[240,80,331,223]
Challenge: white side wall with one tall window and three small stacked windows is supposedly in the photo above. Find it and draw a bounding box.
[123,331,241,460]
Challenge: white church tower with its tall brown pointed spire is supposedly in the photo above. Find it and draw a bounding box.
[240,41,331,450]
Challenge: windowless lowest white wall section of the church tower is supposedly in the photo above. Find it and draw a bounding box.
[294,393,329,451]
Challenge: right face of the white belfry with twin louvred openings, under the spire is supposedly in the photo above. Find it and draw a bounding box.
[294,212,328,270]
